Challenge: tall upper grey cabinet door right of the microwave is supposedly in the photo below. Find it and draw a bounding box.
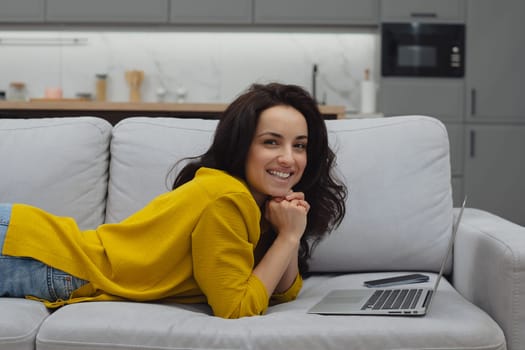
[466,0,525,123]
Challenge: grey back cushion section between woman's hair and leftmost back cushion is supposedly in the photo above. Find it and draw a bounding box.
[106,117,217,222]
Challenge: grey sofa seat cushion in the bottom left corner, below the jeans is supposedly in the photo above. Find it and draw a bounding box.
[0,298,49,350]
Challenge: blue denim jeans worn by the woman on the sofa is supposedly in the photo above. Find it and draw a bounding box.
[0,204,87,301]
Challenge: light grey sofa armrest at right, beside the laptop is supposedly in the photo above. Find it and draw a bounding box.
[452,208,525,350]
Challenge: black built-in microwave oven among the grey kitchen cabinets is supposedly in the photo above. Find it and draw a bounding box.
[381,22,465,77]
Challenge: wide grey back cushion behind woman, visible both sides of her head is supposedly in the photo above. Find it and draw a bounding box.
[106,116,452,272]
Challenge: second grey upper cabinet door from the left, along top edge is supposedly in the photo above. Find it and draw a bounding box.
[46,0,168,24]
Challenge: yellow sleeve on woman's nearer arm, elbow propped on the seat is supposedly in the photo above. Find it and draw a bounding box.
[192,193,269,318]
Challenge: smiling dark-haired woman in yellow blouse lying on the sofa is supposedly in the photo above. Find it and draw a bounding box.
[0,83,346,318]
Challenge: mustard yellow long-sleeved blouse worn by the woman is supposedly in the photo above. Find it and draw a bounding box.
[2,168,302,318]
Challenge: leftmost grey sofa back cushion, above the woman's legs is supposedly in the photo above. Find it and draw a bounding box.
[0,117,112,229]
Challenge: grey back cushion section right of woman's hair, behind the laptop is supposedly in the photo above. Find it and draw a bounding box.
[310,116,453,272]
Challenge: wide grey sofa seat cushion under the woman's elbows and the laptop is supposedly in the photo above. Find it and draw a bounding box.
[37,273,505,350]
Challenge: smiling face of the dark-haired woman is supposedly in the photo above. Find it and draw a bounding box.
[246,106,308,205]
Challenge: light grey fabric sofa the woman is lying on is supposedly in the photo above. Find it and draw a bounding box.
[0,116,525,350]
